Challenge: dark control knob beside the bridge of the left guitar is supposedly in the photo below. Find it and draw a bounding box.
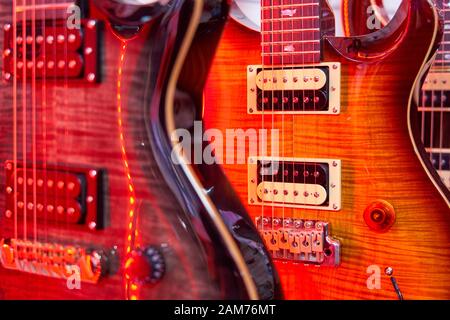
[125,246,166,284]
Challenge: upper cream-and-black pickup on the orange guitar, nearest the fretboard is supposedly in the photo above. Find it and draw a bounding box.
[247,63,341,114]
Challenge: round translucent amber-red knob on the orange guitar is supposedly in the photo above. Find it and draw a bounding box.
[364,200,395,233]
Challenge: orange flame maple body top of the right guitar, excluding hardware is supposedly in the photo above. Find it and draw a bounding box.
[204,0,450,299]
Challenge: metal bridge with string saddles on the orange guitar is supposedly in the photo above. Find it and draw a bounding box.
[256,217,341,266]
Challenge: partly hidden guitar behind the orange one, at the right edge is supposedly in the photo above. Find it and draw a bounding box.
[343,0,450,192]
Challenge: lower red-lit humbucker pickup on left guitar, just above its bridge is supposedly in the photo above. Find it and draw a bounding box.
[5,161,106,229]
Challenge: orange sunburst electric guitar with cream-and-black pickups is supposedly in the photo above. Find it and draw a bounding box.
[204,0,450,299]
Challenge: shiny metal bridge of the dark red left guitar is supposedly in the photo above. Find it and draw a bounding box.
[0,239,108,283]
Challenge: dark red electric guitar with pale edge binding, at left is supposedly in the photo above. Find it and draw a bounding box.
[0,0,277,299]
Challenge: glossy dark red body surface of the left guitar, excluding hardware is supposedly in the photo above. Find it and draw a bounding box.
[0,0,260,299]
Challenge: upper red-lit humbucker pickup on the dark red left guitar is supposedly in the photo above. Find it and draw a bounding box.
[3,19,102,83]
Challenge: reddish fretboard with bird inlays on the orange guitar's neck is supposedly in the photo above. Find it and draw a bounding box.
[261,0,321,65]
